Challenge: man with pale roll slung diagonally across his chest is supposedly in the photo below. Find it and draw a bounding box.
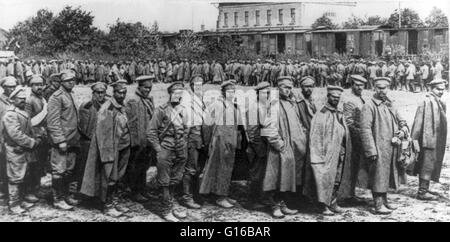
[25,75,50,203]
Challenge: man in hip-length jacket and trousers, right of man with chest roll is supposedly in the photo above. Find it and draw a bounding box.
[47,70,80,210]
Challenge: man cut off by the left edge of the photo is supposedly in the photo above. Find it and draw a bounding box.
[0,76,17,205]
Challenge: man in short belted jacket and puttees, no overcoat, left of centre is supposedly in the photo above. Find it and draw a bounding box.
[146,82,187,221]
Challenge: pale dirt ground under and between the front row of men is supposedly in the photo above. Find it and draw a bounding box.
[0,84,450,222]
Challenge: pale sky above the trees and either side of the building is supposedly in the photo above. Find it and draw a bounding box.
[0,0,450,32]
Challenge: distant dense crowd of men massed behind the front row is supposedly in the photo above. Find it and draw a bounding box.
[0,57,448,92]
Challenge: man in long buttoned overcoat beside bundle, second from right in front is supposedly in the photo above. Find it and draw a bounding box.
[359,77,407,214]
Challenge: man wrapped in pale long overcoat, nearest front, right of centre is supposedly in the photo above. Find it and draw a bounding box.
[309,85,352,215]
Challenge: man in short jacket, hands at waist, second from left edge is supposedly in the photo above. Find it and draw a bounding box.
[1,88,42,214]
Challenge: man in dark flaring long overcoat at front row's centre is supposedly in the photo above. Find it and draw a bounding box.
[199,80,246,208]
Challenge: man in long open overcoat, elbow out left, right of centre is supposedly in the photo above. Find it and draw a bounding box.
[261,76,307,218]
